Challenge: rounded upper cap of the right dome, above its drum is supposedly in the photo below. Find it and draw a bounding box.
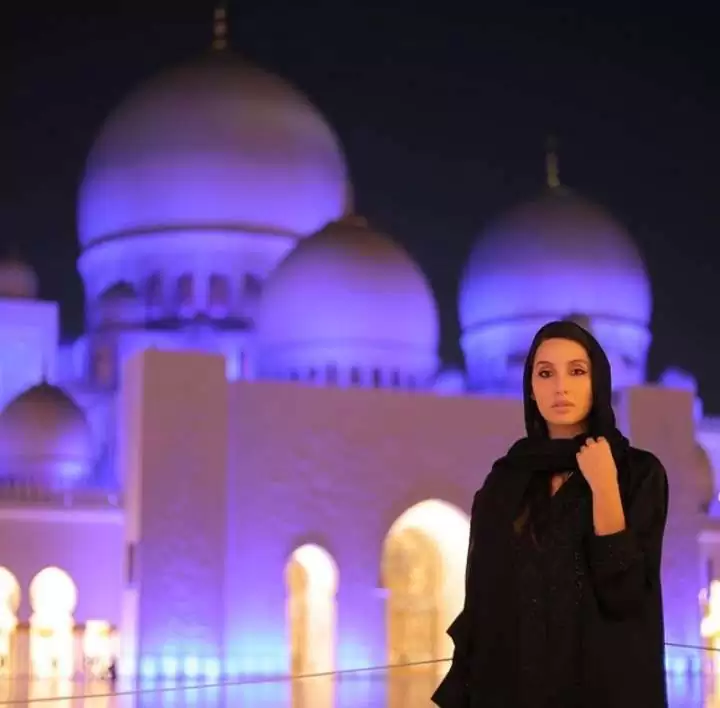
[459,188,652,331]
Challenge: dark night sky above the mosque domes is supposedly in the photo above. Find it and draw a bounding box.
[5,6,720,413]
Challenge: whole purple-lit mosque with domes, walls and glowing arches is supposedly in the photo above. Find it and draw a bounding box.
[0,6,720,692]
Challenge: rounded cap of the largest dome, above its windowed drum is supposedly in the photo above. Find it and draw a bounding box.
[78,52,348,247]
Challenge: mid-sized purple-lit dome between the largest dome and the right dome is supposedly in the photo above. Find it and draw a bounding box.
[258,217,439,387]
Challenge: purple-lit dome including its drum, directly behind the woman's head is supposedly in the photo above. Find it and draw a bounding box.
[459,184,652,393]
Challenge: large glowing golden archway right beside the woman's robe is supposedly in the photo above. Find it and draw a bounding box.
[382,499,470,673]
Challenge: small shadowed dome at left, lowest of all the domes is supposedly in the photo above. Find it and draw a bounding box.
[0,382,93,487]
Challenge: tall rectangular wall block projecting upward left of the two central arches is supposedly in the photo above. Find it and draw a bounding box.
[118,350,228,675]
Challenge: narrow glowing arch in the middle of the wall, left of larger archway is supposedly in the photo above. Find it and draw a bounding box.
[285,544,338,676]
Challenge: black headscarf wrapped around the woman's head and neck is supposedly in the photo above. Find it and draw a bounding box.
[506,320,628,472]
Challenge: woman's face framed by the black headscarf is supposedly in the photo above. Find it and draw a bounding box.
[532,339,592,438]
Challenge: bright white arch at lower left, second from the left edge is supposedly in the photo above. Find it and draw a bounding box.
[30,567,77,679]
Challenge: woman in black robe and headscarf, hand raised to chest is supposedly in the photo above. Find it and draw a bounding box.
[433,322,668,708]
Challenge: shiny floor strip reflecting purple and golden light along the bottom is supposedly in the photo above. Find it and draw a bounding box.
[0,666,720,708]
